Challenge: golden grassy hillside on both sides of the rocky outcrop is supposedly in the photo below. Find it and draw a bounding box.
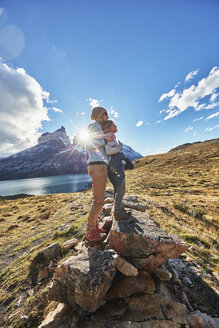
[0,139,219,327]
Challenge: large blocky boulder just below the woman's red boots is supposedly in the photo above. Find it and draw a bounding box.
[49,248,117,312]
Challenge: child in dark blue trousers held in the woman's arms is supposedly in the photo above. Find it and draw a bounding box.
[102,120,131,221]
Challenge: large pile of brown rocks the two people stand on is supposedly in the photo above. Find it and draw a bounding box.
[37,195,219,328]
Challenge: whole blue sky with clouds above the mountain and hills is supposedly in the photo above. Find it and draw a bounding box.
[0,0,219,156]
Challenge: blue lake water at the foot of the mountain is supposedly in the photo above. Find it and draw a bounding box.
[0,174,91,196]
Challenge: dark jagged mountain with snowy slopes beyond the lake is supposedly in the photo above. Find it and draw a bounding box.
[0,126,142,180]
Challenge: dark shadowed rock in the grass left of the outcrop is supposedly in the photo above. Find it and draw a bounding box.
[29,243,61,285]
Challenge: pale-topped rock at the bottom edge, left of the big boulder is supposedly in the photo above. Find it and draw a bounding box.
[38,303,79,328]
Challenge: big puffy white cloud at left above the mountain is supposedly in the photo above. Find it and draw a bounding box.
[0,62,53,155]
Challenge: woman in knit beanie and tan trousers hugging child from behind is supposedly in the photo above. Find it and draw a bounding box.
[85,107,113,242]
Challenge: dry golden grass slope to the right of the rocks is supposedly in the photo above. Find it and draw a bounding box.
[126,139,219,283]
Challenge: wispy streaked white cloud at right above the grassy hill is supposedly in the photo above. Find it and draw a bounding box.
[161,67,219,120]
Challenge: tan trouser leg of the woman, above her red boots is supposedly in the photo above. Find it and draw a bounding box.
[86,164,107,232]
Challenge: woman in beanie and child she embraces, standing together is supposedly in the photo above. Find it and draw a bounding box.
[82,107,131,242]
